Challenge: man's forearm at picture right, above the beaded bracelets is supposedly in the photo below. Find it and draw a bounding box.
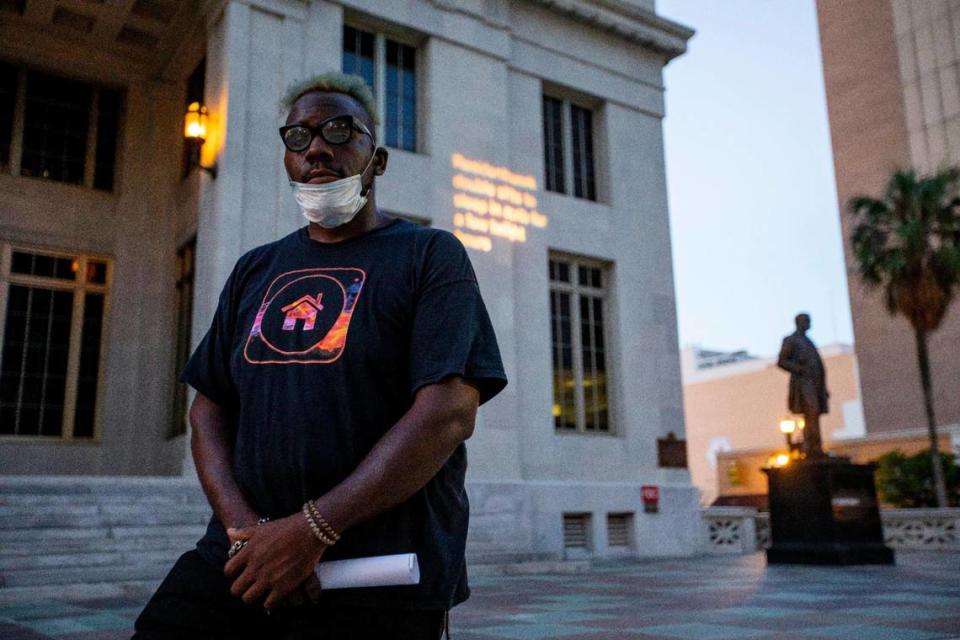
[315,378,479,532]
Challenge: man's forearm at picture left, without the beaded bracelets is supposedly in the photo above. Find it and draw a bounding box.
[190,393,259,527]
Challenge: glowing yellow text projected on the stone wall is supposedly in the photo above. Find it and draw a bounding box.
[451,153,547,251]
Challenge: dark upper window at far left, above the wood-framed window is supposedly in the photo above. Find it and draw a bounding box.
[0,63,123,191]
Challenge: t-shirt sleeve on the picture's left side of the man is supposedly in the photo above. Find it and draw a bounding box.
[180,268,239,408]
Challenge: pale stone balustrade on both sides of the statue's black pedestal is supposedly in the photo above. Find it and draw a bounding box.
[702,507,960,554]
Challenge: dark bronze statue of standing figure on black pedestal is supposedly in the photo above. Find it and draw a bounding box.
[777,313,830,458]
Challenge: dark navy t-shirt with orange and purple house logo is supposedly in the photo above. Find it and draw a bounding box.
[181,219,506,608]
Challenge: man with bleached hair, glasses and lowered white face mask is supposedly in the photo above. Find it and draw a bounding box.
[135,74,506,640]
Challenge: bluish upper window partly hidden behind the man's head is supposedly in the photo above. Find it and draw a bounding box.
[343,25,417,151]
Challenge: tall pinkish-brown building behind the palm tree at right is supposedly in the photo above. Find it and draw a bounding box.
[817,0,960,433]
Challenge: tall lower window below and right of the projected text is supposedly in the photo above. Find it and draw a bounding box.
[549,256,610,433]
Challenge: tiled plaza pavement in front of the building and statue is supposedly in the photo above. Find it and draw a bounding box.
[0,552,960,640]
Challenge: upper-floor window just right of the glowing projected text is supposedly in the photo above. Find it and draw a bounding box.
[543,95,597,200]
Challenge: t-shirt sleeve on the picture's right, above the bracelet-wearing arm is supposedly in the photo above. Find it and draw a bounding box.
[410,232,507,404]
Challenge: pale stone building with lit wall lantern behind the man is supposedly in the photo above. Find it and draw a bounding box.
[0,0,699,555]
